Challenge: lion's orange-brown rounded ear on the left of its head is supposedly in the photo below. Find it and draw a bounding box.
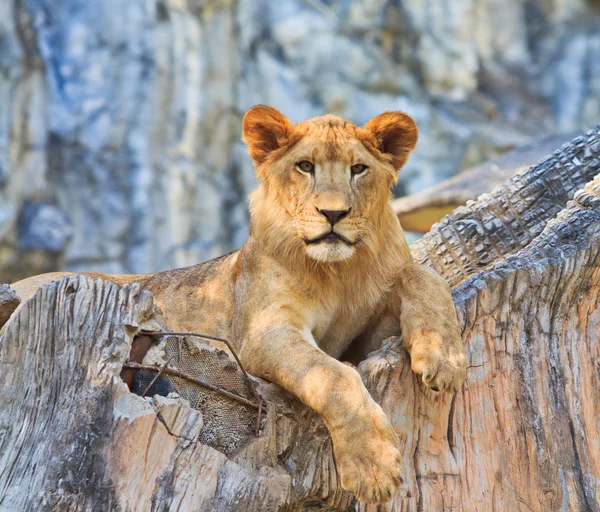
[242,105,293,165]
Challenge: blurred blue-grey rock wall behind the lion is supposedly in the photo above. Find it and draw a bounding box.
[0,0,600,282]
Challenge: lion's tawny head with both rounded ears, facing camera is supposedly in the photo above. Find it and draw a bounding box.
[243,105,418,263]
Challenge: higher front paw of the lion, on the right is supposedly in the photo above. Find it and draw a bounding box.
[411,333,467,392]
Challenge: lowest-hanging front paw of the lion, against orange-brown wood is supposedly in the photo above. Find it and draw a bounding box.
[333,412,402,503]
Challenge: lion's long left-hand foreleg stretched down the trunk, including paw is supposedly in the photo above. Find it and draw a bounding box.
[241,324,401,503]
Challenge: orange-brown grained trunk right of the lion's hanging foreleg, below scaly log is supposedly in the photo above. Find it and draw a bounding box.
[361,172,600,512]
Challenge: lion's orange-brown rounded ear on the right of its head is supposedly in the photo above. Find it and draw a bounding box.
[363,112,419,170]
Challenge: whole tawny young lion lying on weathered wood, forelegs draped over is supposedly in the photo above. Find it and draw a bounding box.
[13,106,465,503]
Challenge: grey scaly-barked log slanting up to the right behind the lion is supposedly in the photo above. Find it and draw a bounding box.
[411,126,600,286]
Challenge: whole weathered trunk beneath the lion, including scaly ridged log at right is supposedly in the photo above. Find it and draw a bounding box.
[0,125,600,512]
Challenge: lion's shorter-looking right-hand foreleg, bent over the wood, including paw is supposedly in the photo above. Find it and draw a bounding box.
[391,265,466,391]
